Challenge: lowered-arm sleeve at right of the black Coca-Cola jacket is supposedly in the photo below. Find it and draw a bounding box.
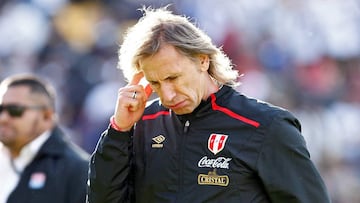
[257,112,330,203]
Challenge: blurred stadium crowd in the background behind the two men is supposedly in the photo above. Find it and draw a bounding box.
[0,0,360,203]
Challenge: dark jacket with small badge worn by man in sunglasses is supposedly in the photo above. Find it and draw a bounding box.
[6,127,89,203]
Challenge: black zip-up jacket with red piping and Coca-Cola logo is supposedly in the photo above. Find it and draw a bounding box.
[89,86,330,203]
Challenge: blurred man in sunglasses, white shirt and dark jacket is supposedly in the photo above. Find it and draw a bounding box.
[0,75,89,203]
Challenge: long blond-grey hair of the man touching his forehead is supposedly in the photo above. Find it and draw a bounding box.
[118,7,239,86]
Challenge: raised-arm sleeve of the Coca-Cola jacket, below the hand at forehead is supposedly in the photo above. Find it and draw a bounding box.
[87,127,132,203]
